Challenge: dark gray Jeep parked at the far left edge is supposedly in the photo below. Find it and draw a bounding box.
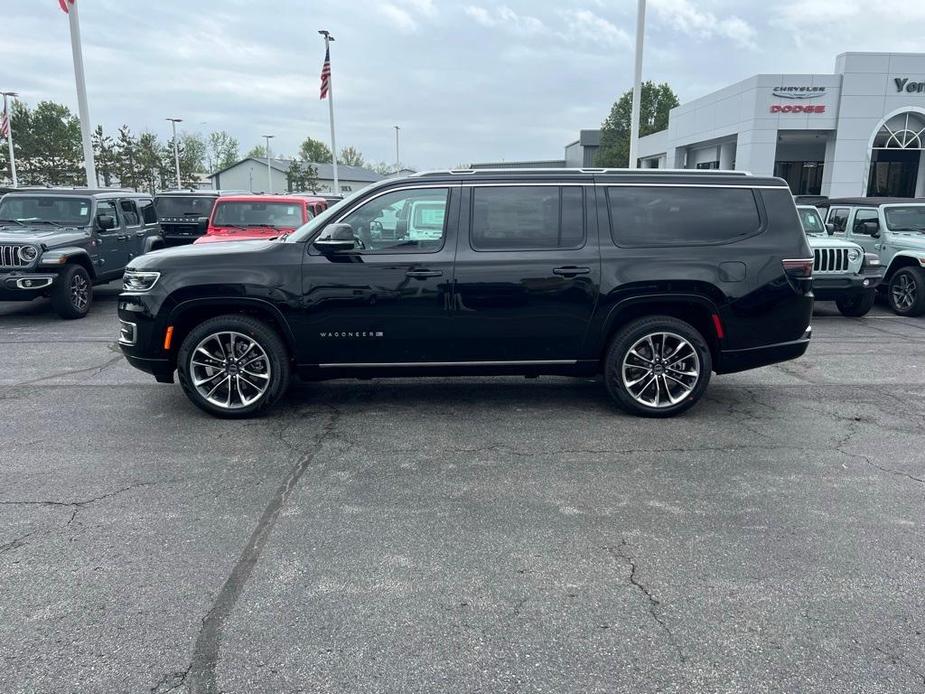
[0,188,163,318]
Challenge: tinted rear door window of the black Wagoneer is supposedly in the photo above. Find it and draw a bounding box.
[471,186,585,251]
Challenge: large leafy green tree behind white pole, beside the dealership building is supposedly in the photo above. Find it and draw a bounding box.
[594,82,681,167]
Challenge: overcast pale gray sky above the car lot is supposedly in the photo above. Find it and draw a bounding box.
[0,0,925,168]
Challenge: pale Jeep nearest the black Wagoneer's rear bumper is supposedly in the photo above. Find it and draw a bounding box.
[797,205,883,317]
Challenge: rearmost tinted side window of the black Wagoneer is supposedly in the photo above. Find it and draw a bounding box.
[607,186,761,248]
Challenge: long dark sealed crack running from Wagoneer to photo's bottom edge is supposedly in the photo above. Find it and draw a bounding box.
[179,409,341,694]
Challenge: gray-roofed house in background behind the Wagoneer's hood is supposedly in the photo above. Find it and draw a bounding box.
[209,157,384,195]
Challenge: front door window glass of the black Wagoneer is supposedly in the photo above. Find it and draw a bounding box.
[340,188,449,253]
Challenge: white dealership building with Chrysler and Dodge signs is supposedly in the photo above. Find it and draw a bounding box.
[638,53,925,197]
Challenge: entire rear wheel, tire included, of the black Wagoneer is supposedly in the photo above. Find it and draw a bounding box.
[604,316,713,417]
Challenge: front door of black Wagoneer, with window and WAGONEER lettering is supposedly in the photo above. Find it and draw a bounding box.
[298,186,459,365]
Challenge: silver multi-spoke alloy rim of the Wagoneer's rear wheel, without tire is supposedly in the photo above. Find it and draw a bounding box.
[621,332,700,408]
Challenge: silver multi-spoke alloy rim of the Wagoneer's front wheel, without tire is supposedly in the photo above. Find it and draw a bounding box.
[190,330,270,410]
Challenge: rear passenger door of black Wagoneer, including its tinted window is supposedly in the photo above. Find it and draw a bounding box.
[450,185,600,361]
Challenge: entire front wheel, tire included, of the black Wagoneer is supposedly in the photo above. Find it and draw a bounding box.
[177,315,290,419]
